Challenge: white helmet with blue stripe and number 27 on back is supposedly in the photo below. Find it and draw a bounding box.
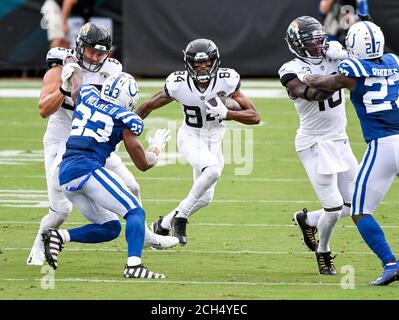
[345,21,385,59]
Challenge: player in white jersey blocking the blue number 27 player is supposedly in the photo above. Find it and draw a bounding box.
[279,16,358,275]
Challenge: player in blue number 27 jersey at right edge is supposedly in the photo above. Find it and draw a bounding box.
[300,21,399,286]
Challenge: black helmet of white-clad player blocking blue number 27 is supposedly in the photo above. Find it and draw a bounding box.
[285,16,327,64]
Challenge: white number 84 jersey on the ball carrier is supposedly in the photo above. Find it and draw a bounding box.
[165,68,240,135]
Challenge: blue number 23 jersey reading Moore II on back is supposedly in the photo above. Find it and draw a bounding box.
[59,85,144,185]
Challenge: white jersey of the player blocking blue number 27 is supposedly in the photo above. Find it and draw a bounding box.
[278,58,348,151]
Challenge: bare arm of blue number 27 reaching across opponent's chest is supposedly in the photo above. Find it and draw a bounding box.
[303,73,356,91]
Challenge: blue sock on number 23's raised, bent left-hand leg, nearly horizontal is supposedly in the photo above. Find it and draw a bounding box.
[68,220,122,243]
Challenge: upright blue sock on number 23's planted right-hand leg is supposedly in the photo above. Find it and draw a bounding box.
[123,207,145,257]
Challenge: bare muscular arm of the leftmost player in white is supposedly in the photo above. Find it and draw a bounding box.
[39,66,65,118]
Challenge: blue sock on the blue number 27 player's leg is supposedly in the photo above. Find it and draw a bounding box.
[357,215,396,265]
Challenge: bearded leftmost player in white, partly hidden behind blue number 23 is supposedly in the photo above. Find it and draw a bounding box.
[27,22,176,265]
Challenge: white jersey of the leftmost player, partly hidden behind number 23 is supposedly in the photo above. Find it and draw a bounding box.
[44,48,122,142]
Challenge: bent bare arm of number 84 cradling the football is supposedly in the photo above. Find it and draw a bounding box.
[226,89,260,124]
